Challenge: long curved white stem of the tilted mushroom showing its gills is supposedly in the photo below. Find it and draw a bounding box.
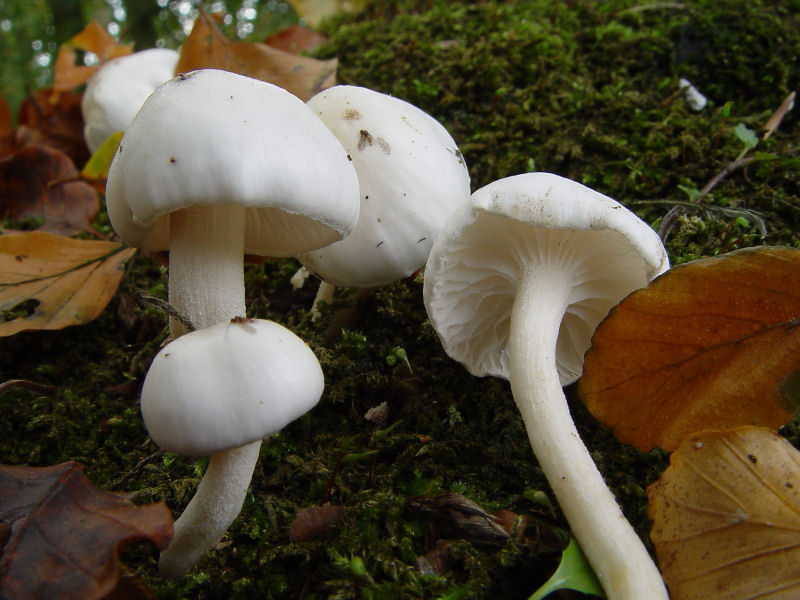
[508,263,668,600]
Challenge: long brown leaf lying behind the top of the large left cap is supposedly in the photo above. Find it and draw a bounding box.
[175,11,337,101]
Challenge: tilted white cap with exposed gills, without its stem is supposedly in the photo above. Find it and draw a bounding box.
[423,173,669,385]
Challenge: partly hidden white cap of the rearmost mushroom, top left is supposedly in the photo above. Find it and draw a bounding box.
[81,48,178,152]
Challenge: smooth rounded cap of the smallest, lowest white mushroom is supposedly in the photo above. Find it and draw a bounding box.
[141,319,324,456]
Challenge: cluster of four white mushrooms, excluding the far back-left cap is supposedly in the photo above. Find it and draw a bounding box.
[107,61,669,600]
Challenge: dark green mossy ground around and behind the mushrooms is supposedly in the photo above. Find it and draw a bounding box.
[0,0,800,600]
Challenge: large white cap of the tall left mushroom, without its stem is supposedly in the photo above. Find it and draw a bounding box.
[106,69,359,257]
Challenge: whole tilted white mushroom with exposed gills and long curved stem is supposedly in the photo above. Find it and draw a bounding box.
[424,173,669,600]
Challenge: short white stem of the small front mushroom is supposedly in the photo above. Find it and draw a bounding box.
[158,440,261,579]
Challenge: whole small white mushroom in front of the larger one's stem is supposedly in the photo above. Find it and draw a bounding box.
[141,319,324,577]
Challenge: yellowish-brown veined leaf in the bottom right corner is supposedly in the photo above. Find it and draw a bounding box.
[647,427,800,600]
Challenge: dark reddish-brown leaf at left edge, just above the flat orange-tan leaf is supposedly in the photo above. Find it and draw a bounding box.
[0,146,100,235]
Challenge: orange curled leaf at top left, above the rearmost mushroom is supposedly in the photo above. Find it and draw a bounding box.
[53,21,133,92]
